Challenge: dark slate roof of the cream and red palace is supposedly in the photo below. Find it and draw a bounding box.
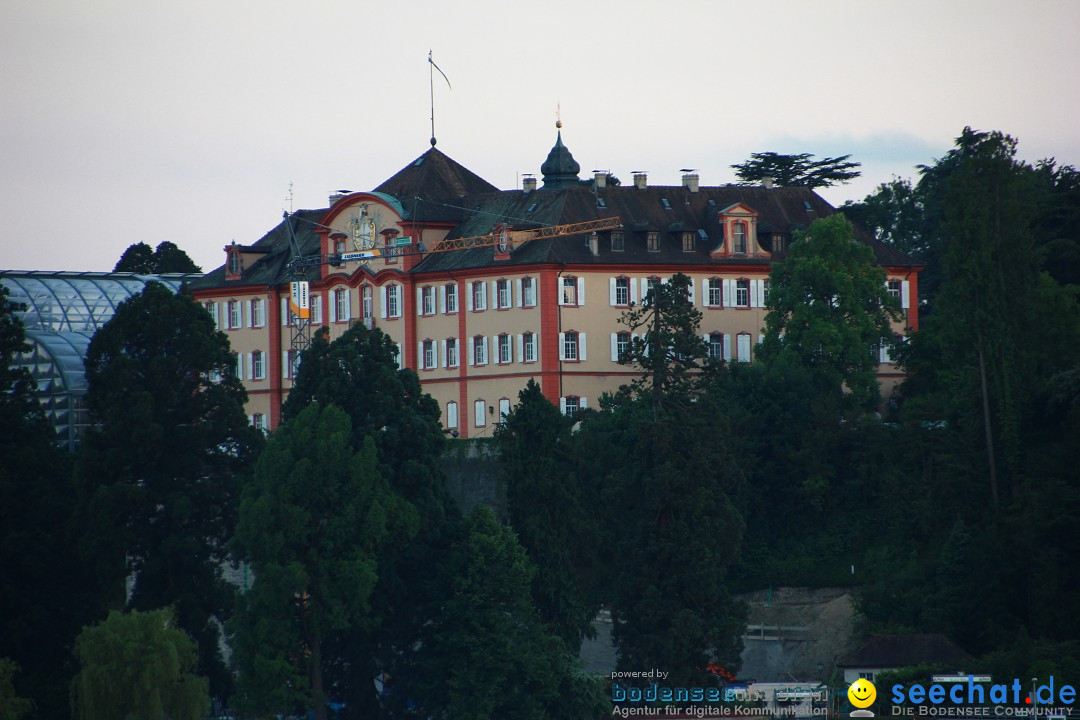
[191,142,919,289]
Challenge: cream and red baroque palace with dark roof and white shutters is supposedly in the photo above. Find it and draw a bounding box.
[190,134,919,437]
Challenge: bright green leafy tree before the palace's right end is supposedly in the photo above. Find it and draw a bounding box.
[758,215,901,410]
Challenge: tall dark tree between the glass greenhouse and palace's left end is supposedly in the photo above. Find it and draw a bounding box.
[80,283,261,695]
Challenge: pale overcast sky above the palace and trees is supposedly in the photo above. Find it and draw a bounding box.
[0,0,1080,271]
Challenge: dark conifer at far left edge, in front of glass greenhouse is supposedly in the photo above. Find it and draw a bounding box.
[0,286,100,717]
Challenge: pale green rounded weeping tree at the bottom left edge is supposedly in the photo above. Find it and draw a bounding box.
[71,609,210,720]
